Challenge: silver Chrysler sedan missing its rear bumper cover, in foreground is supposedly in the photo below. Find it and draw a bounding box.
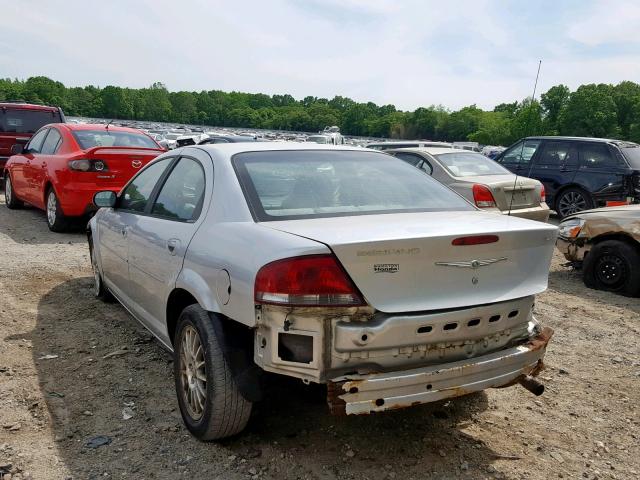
[87,143,556,440]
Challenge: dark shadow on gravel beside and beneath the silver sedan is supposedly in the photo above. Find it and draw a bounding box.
[21,277,512,479]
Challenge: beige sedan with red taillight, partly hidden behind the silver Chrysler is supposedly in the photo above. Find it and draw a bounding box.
[385,147,550,222]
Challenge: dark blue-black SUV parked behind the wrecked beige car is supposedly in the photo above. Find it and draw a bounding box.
[495,137,640,218]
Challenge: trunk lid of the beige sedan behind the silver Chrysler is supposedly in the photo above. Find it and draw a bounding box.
[464,175,542,210]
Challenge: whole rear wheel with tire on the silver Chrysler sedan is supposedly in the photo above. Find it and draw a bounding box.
[173,305,252,441]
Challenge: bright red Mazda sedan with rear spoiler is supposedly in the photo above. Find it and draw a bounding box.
[4,123,165,232]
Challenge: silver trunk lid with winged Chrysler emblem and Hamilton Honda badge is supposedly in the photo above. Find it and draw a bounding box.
[263,211,557,313]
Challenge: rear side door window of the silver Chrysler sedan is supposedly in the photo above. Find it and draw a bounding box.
[151,158,204,222]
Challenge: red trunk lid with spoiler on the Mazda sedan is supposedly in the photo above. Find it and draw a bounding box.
[82,147,164,187]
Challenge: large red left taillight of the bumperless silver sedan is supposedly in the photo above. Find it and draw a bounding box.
[255,255,365,307]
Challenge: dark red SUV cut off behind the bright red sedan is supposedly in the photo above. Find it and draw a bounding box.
[0,102,65,177]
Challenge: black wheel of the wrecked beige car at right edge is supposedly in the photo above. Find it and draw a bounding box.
[582,240,640,297]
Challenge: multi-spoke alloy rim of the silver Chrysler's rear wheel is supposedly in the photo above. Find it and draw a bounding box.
[180,325,207,420]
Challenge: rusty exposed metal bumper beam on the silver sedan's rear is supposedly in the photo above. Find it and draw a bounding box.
[329,327,553,415]
